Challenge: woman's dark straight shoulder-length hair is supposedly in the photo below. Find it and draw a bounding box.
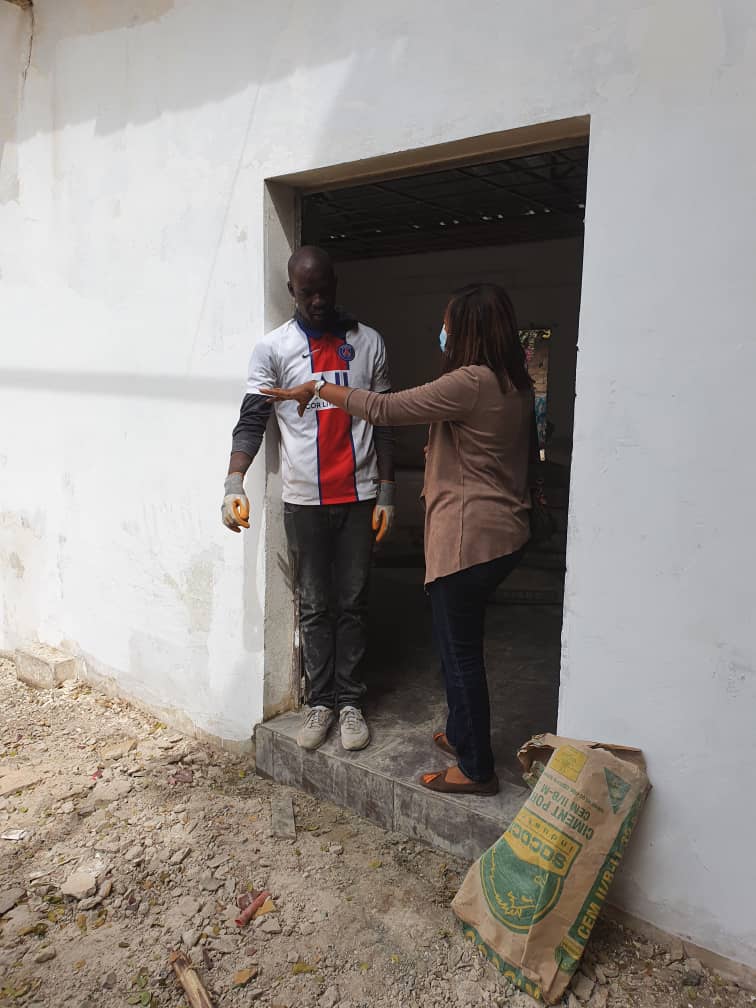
[443,283,533,392]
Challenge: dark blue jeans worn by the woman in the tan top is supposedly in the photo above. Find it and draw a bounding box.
[427,550,522,782]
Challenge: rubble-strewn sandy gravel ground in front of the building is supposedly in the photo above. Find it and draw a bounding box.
[0,660,756,1008]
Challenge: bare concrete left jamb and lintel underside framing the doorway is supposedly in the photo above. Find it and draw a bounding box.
[263,116,590,721]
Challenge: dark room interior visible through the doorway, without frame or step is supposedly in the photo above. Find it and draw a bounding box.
[301,141,588,782]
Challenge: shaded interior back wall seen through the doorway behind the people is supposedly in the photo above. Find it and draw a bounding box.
[338,238,583,468]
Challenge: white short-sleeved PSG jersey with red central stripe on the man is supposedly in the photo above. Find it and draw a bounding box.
[247,319,391,504]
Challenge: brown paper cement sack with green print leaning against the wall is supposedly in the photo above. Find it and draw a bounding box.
[452,735,649,1004]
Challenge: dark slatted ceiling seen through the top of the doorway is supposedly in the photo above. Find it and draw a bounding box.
[302,144,588,260]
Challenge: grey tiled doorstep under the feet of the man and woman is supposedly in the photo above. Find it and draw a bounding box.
[255,713,527,861]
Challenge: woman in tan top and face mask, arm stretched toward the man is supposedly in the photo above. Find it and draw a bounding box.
[260,283,533,794]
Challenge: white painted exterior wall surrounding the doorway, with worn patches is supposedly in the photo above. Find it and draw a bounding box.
[0,0,756,966]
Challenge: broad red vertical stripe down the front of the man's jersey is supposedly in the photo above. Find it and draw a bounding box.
[308,333,359,504]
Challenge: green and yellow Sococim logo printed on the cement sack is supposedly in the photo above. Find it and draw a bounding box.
[481,808,582,932]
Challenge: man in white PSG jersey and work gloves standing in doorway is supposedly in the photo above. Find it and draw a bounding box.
[222,246,394,750]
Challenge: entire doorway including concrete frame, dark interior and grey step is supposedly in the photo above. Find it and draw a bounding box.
[255,117,590,859]
